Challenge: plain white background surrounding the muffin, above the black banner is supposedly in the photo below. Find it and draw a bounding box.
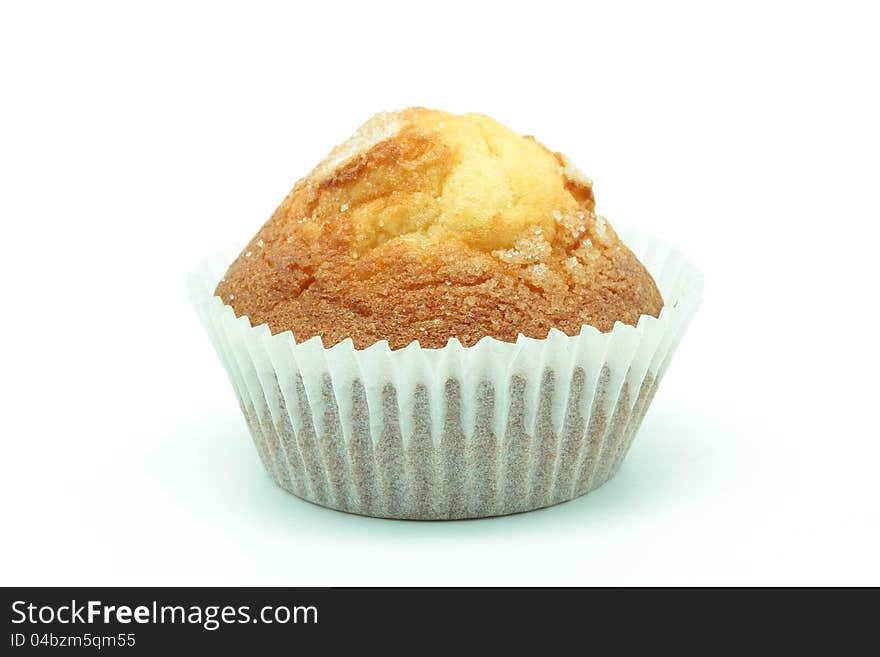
[0,0,880,585]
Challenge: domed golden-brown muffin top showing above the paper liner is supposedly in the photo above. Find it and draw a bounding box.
[215,108,663,349]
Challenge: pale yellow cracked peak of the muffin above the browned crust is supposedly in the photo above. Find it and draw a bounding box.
[307,108,593,255]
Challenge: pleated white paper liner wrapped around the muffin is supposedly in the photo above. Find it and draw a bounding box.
[188,227,702,519]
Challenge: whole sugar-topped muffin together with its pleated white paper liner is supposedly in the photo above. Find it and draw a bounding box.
[189,108,701,519]
